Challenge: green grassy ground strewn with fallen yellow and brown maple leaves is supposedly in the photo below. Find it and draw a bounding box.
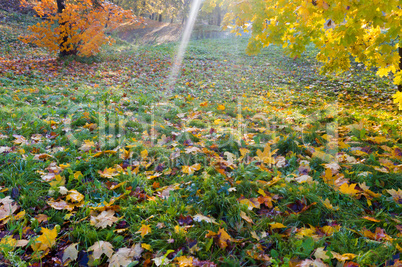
[0,11,402,267]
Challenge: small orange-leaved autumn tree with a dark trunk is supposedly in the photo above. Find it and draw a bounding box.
[21,0,140,56]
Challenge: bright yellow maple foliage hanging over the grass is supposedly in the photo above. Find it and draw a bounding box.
[225,0,402,110]
